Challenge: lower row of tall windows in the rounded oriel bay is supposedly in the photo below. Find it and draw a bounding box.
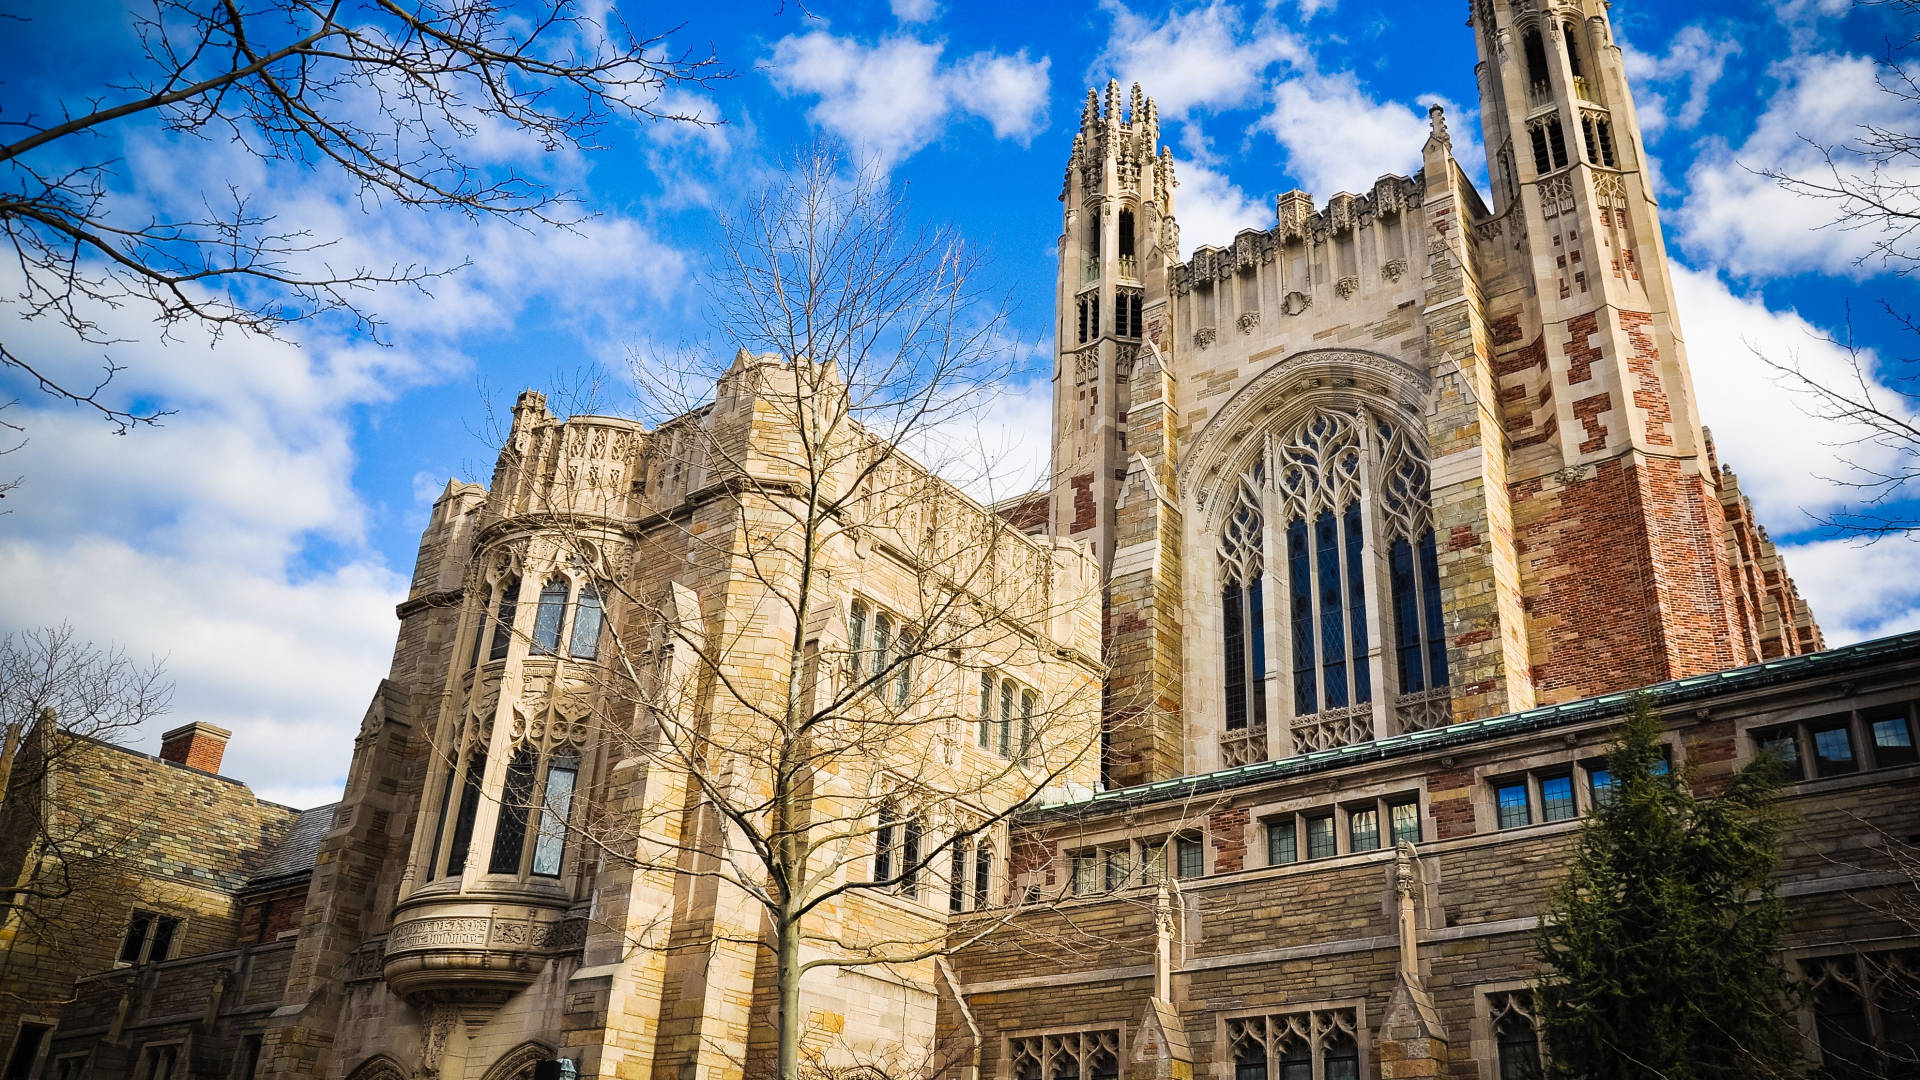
[428,744,580,878]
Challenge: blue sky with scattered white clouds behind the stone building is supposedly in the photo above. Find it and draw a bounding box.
[0,0,1920,805]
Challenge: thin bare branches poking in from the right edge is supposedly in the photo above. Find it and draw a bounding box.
[1753,0,1920,540]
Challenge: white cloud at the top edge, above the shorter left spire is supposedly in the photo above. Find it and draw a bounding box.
[1089,0,1308,117]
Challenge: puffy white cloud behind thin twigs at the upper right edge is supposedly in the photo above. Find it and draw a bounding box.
[1676,54,1920,277]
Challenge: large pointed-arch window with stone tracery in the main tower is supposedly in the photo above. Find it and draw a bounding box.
[1215,404,1448,765]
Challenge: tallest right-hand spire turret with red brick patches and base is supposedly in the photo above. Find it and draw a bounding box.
[1473,0,1757,687]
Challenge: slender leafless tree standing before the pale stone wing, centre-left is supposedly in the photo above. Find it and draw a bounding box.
[447,152,1144,1080]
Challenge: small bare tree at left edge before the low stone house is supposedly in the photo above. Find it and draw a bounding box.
[0,625,173,1009]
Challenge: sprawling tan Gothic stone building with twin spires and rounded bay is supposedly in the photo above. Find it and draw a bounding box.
[7,0,1920,1080]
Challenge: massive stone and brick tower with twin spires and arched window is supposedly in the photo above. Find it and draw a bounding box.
[1052,0,1820,784]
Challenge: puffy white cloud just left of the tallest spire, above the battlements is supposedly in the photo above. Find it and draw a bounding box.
[1261,73,1428,198]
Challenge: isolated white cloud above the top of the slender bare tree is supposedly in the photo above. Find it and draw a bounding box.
[770,31,1050,167]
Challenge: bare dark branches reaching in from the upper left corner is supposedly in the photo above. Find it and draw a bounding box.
[0,0,724,430]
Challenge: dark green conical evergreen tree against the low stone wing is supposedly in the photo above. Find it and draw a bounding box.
[1540,698,1801,1080]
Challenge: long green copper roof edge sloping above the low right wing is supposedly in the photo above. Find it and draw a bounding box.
[1021,630,1920,821]
